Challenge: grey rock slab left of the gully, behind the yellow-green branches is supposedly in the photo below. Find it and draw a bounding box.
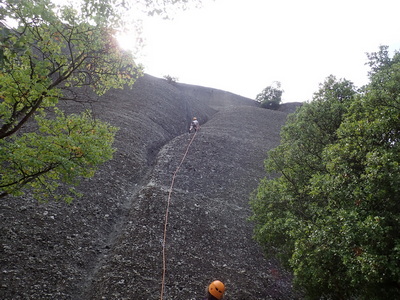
[0,75,216,300]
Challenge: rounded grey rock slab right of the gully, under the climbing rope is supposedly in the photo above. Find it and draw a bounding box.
[88,106,296,300]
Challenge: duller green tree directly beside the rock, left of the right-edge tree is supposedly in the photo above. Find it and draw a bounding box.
[252,76,355,263]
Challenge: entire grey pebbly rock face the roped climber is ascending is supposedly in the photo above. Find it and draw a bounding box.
[0,75,299,300]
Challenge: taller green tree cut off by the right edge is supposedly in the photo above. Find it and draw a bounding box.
[306,46,400,299]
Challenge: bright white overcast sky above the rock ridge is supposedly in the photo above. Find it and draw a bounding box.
[119,0,400,102]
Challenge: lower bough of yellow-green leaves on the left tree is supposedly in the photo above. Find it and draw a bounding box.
[0,109,116,201]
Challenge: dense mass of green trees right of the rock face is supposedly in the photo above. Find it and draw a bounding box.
[252,47,400,299]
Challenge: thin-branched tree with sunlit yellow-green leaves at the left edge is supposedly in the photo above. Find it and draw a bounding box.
[0,0,202,201]
